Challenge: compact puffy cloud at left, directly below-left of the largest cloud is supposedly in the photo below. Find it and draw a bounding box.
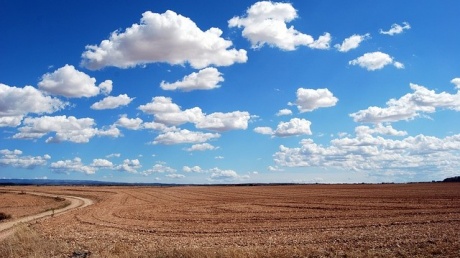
[38,64,112,98]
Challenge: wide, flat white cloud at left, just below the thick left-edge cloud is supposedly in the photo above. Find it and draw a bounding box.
[13,116,120,143]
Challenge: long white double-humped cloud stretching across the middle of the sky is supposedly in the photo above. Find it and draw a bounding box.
[138,96,251,132]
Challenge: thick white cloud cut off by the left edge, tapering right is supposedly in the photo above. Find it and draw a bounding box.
[0,83,68,127]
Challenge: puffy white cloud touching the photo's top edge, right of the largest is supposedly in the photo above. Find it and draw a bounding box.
[228,1,331,51]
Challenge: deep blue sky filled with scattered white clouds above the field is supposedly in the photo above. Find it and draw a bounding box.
[0,0,460,184]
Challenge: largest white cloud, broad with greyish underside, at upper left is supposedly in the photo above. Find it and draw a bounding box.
[81,10,247,70]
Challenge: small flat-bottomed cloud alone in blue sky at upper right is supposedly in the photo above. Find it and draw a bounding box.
[348,51,404,71]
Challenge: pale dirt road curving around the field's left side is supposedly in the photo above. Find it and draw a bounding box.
[0,191,93,241]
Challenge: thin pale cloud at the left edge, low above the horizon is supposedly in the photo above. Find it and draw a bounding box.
[0,149,51,169]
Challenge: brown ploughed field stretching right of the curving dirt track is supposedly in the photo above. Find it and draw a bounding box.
[0,183,460,257]
